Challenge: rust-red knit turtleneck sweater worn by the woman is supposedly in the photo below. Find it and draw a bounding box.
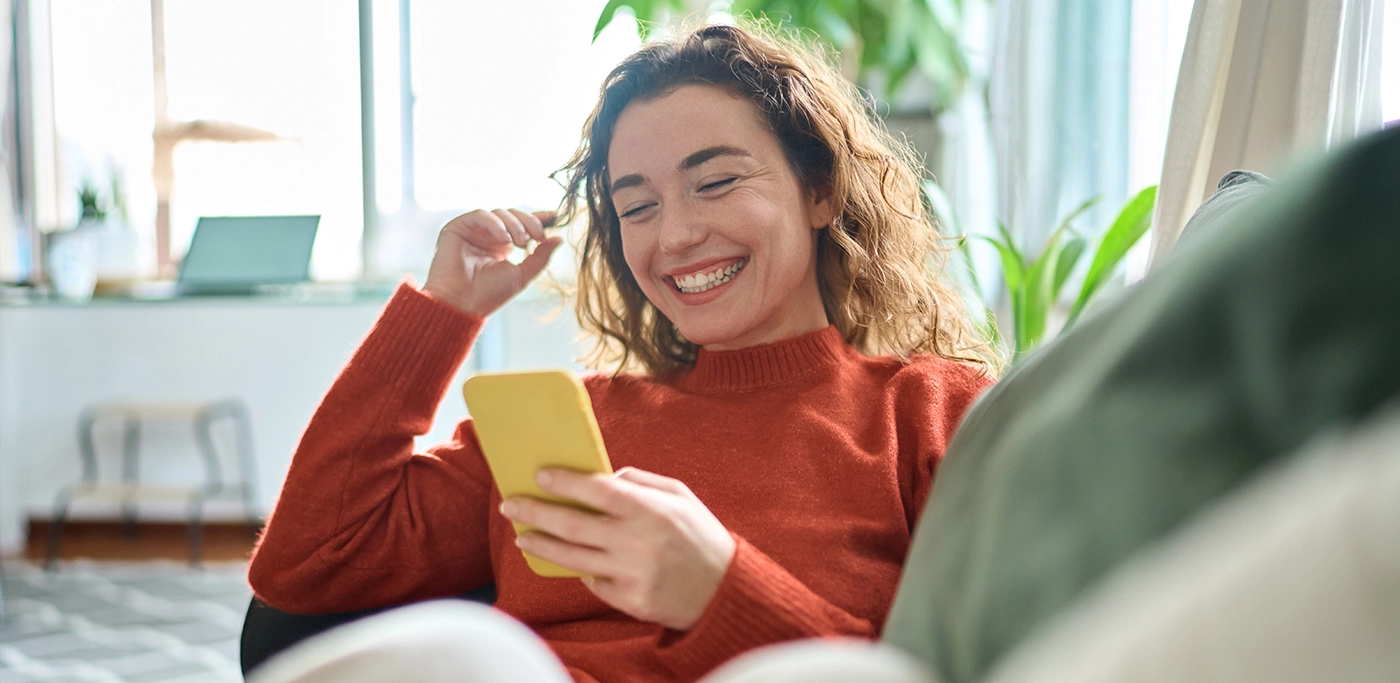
[249,279,990,682]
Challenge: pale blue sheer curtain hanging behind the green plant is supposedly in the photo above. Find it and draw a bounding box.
[990,0,1140,253]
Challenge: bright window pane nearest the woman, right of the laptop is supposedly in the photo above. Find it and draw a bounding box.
[374,0,640,274]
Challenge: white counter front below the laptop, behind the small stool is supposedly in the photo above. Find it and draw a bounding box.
[0,285,578,553]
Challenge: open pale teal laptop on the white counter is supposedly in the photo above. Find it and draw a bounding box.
[175,216,321,295]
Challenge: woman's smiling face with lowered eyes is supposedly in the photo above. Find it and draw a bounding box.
[608,85,830,350]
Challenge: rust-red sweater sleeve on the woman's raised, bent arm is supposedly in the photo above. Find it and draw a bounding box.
[248,284,491,613]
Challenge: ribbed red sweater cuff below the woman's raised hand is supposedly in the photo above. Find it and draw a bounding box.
[350,280,486,386]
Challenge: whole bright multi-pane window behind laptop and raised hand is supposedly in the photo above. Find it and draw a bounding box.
[41,0,638,280]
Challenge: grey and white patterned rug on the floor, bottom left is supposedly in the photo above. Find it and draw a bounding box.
[0,560,252,683]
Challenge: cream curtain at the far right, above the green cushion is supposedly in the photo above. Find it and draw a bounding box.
[1149,0,1385,267]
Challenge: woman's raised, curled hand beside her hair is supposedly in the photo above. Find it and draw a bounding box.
[423,209,563,318]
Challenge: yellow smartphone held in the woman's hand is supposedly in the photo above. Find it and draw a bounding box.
[462,369,612,577]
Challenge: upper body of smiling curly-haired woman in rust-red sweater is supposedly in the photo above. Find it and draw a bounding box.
[249,21,990,682]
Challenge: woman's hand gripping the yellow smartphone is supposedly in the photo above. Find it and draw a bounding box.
[501,467,735,631]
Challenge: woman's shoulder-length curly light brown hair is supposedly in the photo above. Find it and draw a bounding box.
[557,25,1000,376]
